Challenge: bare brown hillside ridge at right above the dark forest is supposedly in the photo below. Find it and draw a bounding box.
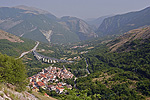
[107,26,150,52]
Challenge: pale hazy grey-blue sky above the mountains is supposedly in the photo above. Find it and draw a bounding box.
[0,0,150,19]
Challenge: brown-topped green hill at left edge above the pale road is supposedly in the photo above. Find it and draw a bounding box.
[0,30,35,57]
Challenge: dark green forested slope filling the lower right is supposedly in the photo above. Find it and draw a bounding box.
[77,31,150,100]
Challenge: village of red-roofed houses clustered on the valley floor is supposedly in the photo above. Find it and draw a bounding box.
[29,66,74,93]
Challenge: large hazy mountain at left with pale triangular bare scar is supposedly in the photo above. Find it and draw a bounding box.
[0,5,96,43]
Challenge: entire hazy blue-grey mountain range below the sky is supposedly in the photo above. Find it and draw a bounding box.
[0,5,150,43]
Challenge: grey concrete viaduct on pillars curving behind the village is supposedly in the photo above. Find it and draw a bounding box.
[32,50,69,63]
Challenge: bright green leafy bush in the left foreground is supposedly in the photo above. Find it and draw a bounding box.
[0,53,27,91]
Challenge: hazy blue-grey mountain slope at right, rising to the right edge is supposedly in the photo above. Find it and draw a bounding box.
[97,7,150,36]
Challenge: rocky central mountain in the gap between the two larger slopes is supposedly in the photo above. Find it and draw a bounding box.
[60,16,97,40]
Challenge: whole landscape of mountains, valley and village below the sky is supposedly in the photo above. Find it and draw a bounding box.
[0,6,150,100]
